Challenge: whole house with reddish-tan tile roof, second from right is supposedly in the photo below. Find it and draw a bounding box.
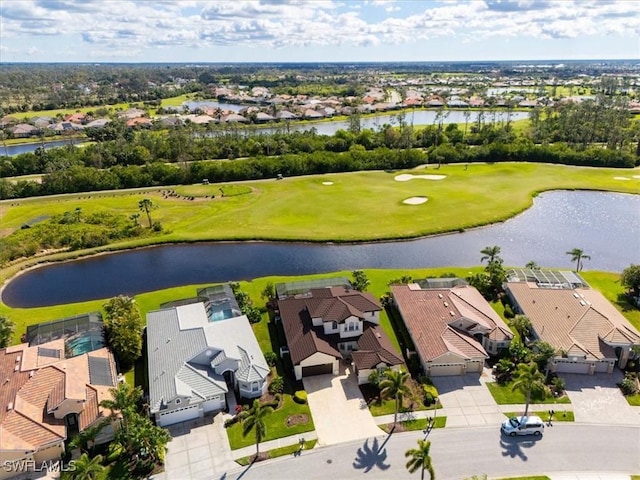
[391,279,513,377]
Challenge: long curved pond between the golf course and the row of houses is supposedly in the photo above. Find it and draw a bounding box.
[2,191,640,307]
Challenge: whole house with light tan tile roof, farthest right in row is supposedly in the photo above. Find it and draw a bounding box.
[504,272,640,374]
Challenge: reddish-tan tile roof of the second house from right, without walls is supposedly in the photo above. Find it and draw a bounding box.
[391,285,502,361]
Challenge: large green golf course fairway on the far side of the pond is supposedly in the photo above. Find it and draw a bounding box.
[0,163,640,280]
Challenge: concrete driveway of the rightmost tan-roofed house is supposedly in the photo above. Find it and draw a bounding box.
[559,369,640,425]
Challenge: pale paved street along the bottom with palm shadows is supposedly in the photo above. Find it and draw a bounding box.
[208,424,640,480]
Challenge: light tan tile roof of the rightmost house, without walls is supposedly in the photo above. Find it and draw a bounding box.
[507,282,640,359]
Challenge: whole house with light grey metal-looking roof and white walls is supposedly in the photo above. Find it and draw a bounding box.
[147,302,270,426]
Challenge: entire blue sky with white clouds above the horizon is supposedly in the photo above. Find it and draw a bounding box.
[0,0,640,62]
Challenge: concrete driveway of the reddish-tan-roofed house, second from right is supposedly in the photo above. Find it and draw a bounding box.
[432,369,505,427]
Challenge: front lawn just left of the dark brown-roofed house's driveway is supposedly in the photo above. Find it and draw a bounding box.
[227,394,315,450]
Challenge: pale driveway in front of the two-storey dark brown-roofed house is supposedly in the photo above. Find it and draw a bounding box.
[302,366,386,445]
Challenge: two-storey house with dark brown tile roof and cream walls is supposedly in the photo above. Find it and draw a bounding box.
[278,286,401,380]
